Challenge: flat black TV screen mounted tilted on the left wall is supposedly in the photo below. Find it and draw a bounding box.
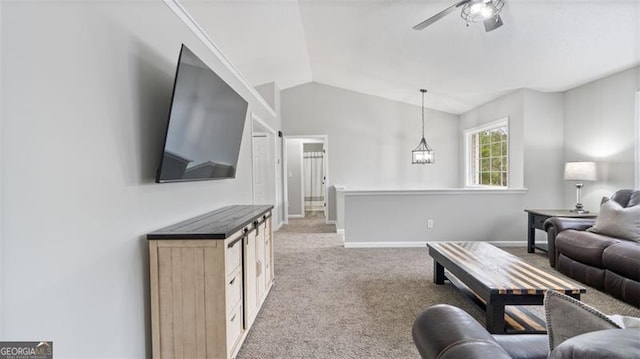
[156,44,248,183]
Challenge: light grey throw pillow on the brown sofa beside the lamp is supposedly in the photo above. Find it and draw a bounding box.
[587,201,640,241]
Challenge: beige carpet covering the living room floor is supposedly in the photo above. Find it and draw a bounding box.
[238,225,640,358]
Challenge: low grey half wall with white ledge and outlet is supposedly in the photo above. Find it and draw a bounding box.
[344,189,527,247]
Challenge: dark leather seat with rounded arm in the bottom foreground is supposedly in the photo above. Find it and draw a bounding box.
[412,304,640,359]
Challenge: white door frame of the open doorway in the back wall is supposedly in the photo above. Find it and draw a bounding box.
[282,135,329,224]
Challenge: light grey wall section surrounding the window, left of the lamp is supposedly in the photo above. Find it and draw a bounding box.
[460,89,563,208]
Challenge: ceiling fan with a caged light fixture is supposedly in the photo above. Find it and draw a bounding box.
[413,0,504,32]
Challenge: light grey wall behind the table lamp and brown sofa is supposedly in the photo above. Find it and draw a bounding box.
[564,67,640,211]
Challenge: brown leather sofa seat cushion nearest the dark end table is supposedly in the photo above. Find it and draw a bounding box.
[555,229,620,268]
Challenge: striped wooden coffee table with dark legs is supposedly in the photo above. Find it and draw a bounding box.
[427,242,586,333]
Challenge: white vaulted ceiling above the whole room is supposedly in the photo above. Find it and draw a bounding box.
[183,0,640,114]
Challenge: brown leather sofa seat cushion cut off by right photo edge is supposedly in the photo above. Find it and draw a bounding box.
[602,241,640,282]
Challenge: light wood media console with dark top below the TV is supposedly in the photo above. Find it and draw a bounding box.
[147,206,274,359]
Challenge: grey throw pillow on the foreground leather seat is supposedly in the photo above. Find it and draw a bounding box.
[544,290,621,352]
